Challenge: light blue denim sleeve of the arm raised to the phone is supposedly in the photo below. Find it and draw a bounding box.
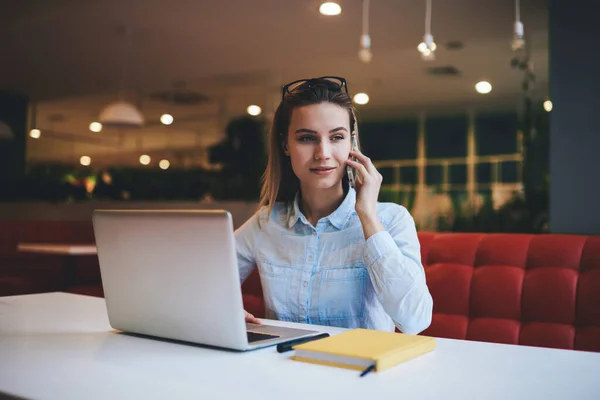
[364,205,433,334]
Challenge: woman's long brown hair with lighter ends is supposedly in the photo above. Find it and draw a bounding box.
[259,85,358,218]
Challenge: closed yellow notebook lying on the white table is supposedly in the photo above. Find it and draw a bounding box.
[292,329,436,371]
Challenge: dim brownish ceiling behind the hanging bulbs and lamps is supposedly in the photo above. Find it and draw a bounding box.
[0,0,548,166]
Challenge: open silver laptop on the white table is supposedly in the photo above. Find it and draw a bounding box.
[92,210,317,350]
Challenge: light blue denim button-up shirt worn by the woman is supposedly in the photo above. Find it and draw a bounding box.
[235,189,433,334]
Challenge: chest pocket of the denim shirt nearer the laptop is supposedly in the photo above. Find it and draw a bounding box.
[259,262,300,321]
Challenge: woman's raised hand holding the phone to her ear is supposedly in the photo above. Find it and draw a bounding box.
[347,151,383,220]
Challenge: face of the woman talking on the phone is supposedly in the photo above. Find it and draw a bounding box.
[285,103,351,189]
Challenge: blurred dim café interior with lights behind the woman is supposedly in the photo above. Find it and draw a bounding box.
[0,0,552,232]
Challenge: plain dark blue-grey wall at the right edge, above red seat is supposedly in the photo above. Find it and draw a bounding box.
[549,0,600,234]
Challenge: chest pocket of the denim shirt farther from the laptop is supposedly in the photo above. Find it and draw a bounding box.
[317,265,369,325]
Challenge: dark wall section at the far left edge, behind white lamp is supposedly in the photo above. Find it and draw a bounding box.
[0,91,27,197]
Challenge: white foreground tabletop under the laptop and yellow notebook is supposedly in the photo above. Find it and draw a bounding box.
[0,293,600,400]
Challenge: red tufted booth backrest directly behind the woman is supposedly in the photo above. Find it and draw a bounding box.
[242,232,600,352]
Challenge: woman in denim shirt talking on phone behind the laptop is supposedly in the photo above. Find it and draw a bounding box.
[236,77,433,334]
